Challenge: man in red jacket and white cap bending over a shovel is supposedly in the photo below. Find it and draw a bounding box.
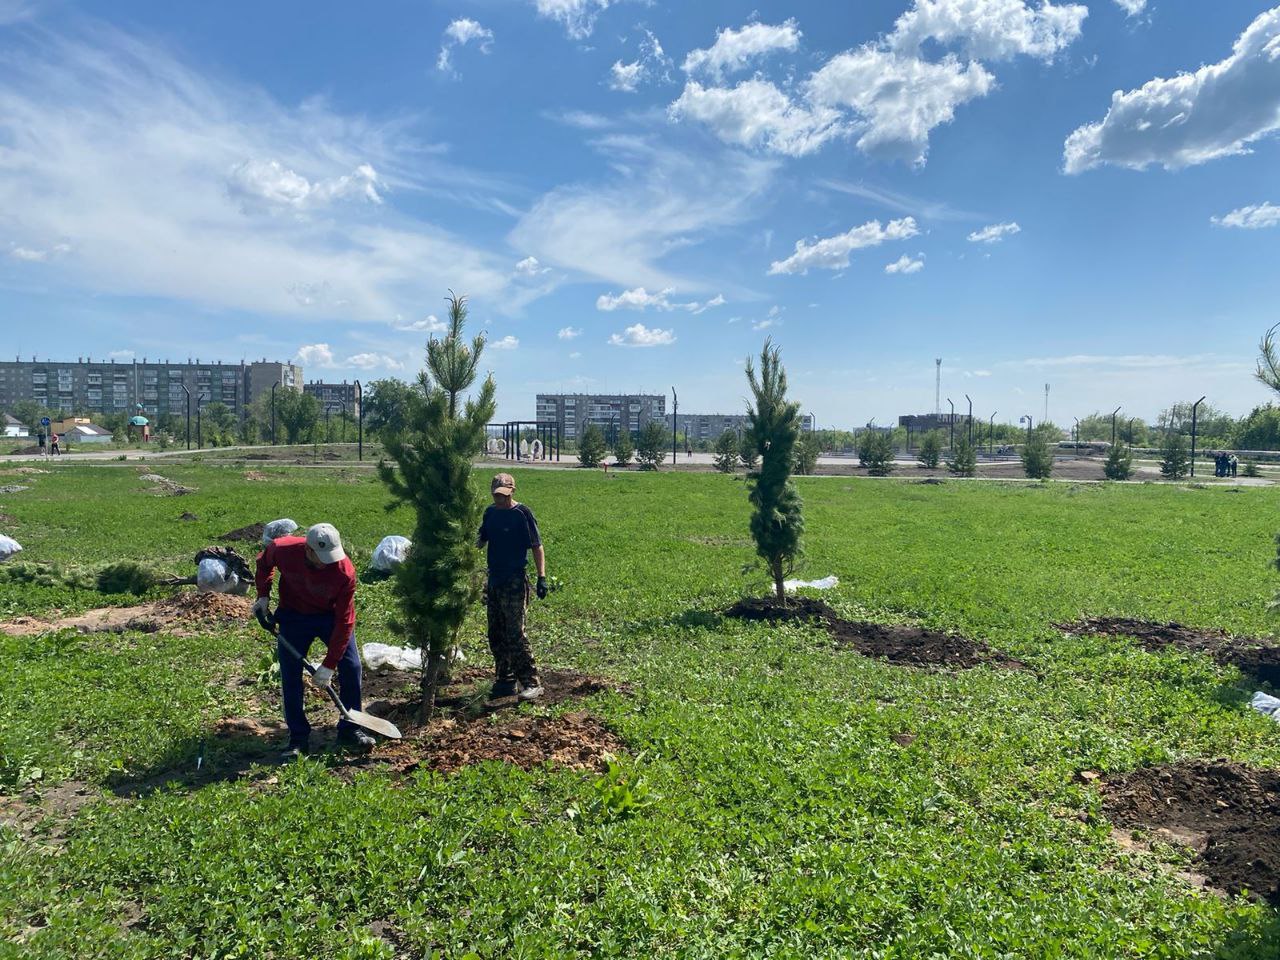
[253,524,374,758]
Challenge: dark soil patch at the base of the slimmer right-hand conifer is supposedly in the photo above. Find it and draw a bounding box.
[724,596,1027,669]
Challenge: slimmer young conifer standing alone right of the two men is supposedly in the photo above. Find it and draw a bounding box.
[746,339,804,603]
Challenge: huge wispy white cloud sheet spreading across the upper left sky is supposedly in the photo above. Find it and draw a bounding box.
[0,24,524,323]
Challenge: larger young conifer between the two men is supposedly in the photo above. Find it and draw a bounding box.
[378,291,495,721]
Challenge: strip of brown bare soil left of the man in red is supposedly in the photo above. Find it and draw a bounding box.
[0,593,252,636]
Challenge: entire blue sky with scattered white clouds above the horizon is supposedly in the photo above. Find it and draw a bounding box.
[0,0,1280,426]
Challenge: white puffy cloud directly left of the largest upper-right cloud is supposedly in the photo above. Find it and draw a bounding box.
[668,78,849,156]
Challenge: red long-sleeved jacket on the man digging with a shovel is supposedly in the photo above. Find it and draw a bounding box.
[256,536,356,669]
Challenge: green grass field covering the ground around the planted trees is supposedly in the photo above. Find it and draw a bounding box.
[0,463,1280,960]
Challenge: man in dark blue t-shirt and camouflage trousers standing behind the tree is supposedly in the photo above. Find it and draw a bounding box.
[476,474,547,700]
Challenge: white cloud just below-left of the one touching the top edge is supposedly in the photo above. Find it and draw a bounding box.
[806,45,996,165]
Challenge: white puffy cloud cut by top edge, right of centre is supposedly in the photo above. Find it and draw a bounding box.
[888,0,1089,61]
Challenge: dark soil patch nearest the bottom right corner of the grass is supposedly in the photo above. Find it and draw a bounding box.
[1102,760,1280,906]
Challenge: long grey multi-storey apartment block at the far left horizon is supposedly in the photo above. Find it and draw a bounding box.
[0,357,302,417]
